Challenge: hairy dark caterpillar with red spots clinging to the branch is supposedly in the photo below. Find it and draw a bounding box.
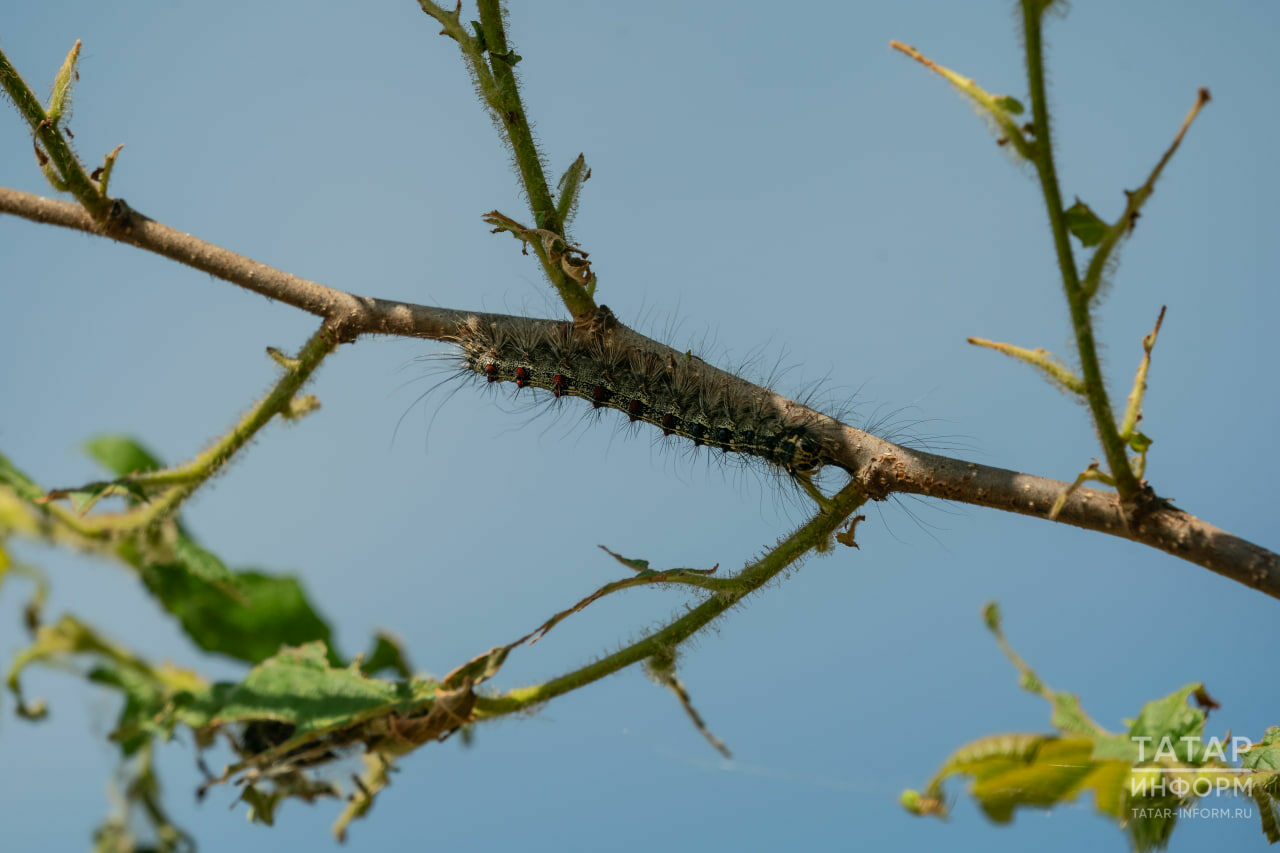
[454,306,842,476]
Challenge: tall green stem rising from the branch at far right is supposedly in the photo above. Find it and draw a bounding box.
[1021,0,1140,498]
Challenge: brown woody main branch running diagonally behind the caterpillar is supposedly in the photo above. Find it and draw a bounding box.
[0,187,1280,598]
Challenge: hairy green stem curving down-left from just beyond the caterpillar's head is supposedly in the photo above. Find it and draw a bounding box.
[476,482,867,717]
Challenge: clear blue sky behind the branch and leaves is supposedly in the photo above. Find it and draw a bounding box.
[0,0,1280,853]
